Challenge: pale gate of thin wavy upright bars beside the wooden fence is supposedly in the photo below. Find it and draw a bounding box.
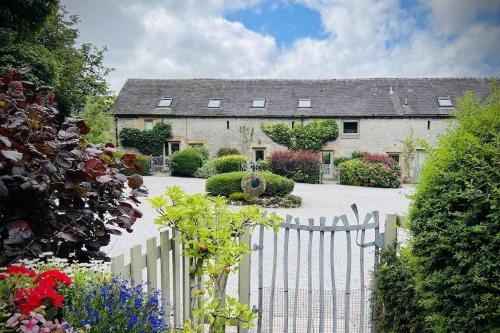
[252,204,384,333]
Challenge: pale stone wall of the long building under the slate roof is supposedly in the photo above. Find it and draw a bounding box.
[117,117,449,159]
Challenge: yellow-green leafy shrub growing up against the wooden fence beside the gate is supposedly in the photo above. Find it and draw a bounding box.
[148,186,281,333]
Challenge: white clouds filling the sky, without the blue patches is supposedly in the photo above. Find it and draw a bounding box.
[95,0,500,90]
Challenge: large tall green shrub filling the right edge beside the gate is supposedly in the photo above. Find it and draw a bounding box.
[409,87,500,332]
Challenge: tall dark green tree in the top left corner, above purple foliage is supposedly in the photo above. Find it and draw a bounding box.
[0,0,110,120]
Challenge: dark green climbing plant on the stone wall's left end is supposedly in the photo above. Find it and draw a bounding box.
[120,121,172,156]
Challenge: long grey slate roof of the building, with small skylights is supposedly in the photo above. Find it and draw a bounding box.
[112,78,489,117]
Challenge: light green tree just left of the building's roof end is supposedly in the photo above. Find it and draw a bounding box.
[79,96,115,144]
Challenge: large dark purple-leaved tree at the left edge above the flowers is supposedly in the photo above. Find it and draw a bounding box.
[0,72,147,266]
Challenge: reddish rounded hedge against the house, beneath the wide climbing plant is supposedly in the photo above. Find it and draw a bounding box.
[269,151,321,184]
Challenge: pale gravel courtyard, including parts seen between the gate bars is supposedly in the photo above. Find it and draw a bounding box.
[105,177,413,332]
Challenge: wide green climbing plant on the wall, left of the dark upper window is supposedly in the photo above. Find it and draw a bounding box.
[261,120,339,151]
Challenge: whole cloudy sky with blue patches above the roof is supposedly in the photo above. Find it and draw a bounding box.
[63,0,500,92]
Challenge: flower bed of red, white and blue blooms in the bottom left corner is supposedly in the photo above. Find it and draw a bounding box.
[0,258,169,333]
